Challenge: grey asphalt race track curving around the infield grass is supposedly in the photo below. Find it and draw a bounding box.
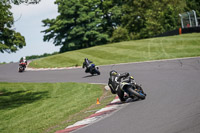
[0,57,200,133]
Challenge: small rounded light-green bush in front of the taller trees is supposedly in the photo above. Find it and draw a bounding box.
[111,27,129,42]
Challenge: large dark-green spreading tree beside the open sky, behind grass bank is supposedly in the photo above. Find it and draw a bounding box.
[42,0,108,52]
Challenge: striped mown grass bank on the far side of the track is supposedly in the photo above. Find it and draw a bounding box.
[30,33,200,68]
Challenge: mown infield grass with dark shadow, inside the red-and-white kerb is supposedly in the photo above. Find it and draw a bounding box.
[0,82,114,133]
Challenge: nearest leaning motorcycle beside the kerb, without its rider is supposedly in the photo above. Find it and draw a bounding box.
[116,76,146,101]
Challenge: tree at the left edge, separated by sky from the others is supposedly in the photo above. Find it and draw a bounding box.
[0,1,26,53]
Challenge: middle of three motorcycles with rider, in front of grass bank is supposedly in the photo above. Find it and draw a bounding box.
[83,58,100,75]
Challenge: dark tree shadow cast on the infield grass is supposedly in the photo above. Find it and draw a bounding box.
[0,91,48,110]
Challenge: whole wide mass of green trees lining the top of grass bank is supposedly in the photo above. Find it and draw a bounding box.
[43,0,200,52]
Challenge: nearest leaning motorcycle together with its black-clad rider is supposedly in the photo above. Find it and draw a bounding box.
[108,71,146,102]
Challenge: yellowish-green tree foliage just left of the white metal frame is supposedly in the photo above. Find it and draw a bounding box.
[122,0,185,38]
